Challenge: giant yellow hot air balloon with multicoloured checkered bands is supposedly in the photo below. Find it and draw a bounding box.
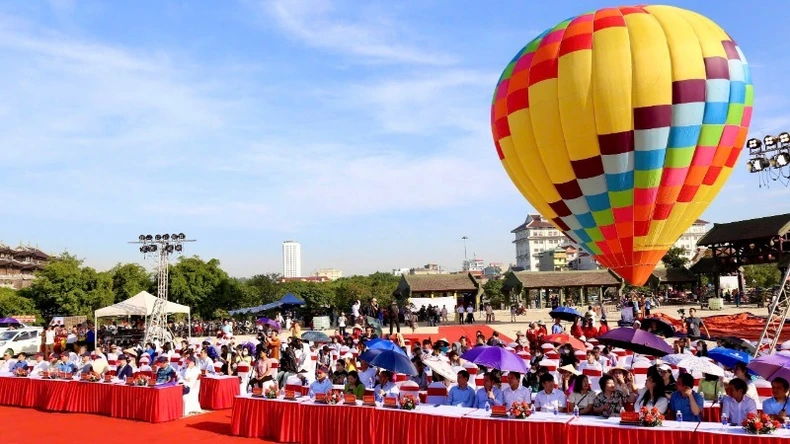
[491,6,754,285]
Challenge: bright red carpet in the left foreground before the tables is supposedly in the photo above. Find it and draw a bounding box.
[0,407,269,444]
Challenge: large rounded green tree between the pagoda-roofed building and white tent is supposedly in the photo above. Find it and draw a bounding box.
[19,253,115,320]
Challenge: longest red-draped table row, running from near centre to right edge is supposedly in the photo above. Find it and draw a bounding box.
[231,395,790,444]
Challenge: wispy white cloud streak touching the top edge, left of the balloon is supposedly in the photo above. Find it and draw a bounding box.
[262,0,455,65]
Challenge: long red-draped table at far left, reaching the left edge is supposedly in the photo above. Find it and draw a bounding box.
[0,376,184,423]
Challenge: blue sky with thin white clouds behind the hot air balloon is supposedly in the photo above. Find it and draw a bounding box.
[0,0,790,276]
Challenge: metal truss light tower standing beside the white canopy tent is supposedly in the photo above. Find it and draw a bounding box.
[129,233,195,345]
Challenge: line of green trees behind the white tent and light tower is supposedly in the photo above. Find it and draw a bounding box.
[0,253,400,321]
